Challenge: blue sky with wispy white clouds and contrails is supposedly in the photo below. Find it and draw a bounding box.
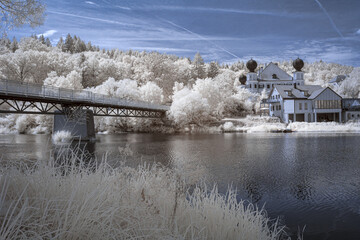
[8,0,360,66]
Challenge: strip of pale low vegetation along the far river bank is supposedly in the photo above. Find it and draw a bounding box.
[0,114,360,134]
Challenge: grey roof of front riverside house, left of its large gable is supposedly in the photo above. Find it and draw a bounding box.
[270,85,324,99]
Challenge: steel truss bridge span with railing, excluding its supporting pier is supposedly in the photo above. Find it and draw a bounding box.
[0,80,169,118]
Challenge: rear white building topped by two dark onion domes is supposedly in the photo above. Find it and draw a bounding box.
[245,58,304,93]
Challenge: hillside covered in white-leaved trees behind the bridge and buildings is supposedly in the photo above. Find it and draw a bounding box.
[0,35,360,132]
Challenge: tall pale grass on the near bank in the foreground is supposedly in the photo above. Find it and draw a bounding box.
[0,151,283,239]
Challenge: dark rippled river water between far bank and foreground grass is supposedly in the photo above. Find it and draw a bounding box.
[0,133,360,239]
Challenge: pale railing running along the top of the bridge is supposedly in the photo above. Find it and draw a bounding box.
[0,80,168,111]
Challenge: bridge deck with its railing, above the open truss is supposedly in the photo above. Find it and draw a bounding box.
[0,80,169,113]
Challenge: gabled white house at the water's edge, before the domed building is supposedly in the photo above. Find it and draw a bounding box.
[268,84,342,123]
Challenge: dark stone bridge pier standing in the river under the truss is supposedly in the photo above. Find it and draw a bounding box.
[53,109,95,141]
